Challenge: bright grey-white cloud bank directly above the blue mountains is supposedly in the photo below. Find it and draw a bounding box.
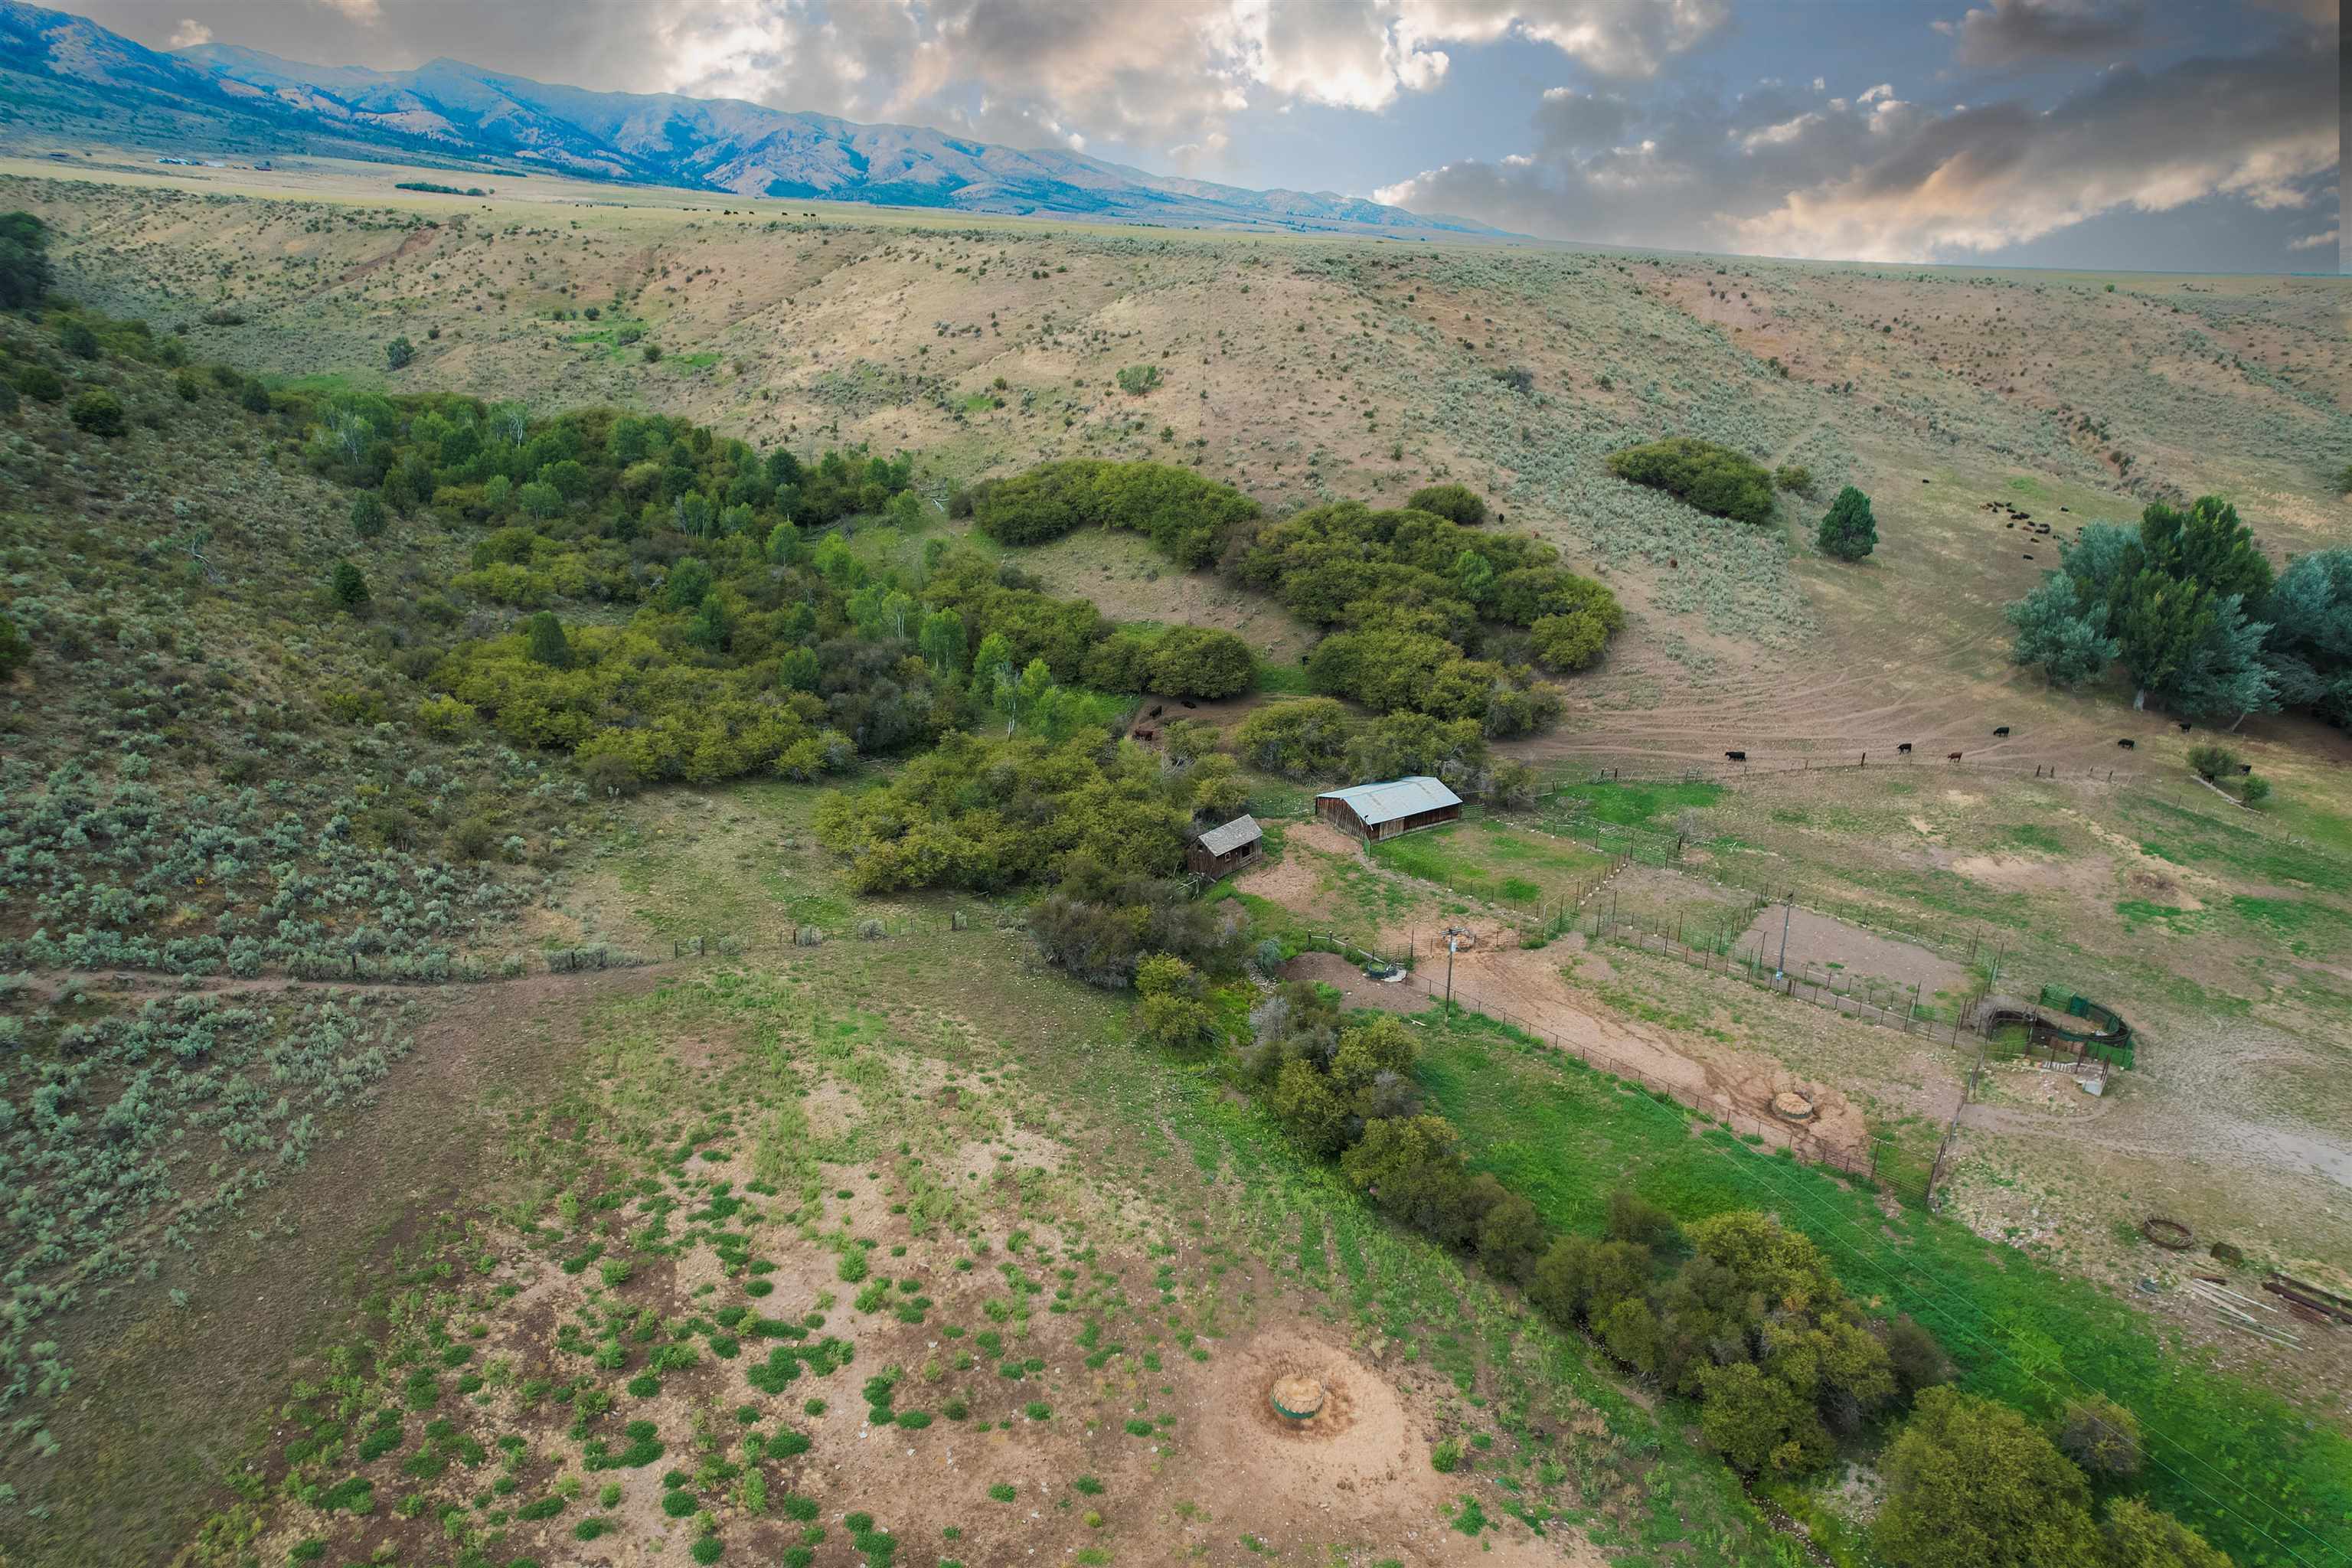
[91,0,1729,162]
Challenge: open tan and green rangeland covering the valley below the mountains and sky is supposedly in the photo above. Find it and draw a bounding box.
[0,151,2352,1568]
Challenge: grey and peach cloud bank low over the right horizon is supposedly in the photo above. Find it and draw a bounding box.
[1378,42,2338,261]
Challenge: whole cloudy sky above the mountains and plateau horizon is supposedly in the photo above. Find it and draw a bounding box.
[68,0,2352,273]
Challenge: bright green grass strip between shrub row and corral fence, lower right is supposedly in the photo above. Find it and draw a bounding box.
[1420,1015,2352,1568]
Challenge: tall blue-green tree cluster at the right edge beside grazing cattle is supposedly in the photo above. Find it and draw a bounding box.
[2006,496,2352,724]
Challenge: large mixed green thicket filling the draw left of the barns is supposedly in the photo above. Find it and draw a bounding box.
[303,395,1253,788]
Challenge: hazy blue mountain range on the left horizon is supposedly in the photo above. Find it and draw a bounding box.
[0,0,1501,235]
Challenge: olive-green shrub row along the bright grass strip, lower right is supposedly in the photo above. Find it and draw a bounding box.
[1237,982,2230,1568]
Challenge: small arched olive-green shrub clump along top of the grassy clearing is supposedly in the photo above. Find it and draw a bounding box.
[955,459,1259,571]
